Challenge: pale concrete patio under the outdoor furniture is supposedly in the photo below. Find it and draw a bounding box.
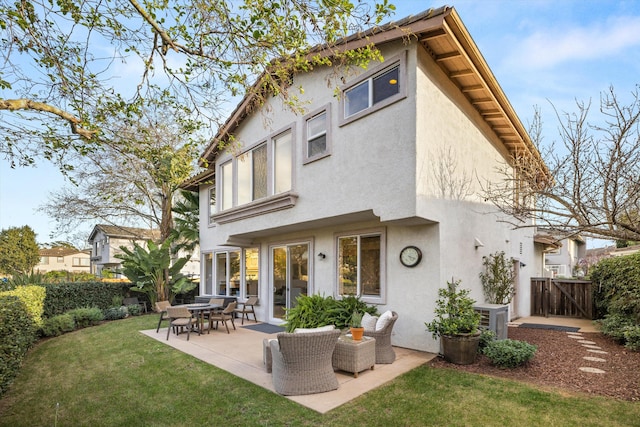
[140,322,436,413]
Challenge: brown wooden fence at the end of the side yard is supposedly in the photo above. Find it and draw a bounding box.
[531,277,593,319]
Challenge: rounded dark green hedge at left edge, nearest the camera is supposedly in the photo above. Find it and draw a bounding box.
[0,294,37,396]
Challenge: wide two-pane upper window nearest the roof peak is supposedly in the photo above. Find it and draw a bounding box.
[341,54,406,124]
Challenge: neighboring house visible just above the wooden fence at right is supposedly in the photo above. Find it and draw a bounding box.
[536,229,587,278]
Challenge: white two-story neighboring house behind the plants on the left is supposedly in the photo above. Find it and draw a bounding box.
[88,224,200,277]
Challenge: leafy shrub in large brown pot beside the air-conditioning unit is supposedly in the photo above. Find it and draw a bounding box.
[425,280,480,365]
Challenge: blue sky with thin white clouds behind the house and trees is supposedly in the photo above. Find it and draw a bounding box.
[0,0,640,247]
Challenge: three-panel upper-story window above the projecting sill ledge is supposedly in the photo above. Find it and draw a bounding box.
[219,129,293,211]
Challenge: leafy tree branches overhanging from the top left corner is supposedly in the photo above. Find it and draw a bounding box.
[0,0,394,170]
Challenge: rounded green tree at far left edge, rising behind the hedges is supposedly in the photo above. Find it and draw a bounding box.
[0,225,40,275]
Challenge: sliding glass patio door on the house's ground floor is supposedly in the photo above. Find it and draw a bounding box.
[271,243,309,320]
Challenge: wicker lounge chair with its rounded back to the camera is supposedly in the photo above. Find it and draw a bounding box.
[270,329,340,396]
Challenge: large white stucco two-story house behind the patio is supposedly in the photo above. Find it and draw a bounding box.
[184,7,542,352]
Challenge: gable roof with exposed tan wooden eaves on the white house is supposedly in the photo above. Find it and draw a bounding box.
[198,6,543,171]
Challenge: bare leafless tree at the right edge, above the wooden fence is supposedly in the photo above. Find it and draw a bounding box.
[485,88,640,244]
